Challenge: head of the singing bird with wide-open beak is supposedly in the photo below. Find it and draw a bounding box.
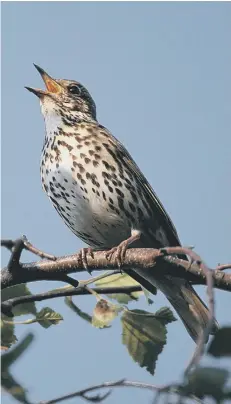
[26,65,96,126]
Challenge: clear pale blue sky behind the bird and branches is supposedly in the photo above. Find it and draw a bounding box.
[2,2,231,404]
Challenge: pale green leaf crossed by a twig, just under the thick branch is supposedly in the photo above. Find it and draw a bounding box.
[95,274,143,304]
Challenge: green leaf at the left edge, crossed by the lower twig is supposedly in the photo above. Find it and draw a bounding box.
[1,284,37,316]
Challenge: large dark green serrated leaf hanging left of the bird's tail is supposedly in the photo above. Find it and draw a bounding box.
[121,310,167,375]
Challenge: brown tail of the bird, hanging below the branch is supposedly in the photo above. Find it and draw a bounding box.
[132,269,219,342]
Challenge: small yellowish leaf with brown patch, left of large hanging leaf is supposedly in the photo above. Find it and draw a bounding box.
[92,299,123,328]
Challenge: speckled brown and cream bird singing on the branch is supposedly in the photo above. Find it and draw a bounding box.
[26,65,218,341]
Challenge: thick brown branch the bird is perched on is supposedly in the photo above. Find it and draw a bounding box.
[1,237,231,291]
